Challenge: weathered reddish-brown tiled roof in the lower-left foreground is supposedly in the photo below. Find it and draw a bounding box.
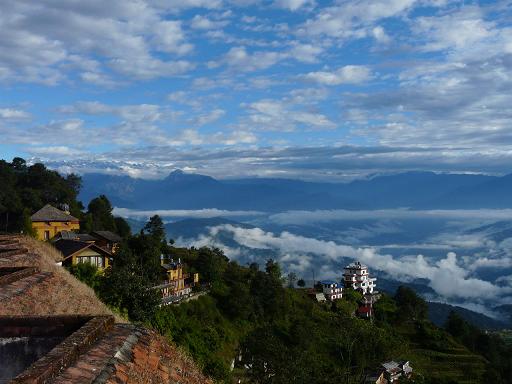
[0,236,211,384]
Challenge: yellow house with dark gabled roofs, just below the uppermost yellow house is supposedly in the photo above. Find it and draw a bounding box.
[53,239,112,270]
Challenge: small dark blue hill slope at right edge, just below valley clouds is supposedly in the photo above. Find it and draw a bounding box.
[428,302,512,329]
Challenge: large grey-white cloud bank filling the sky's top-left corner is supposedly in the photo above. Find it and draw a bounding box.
[0,0,192,85]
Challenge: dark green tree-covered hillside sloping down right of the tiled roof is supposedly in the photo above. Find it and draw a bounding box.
[146,244,512,383]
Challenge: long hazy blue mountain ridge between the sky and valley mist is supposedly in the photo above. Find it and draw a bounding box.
[80,170,512,212]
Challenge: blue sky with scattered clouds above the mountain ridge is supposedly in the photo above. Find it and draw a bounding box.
[0,0,512,180]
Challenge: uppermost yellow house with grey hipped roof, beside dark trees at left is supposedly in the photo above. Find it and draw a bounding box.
[30,204,80,240]
